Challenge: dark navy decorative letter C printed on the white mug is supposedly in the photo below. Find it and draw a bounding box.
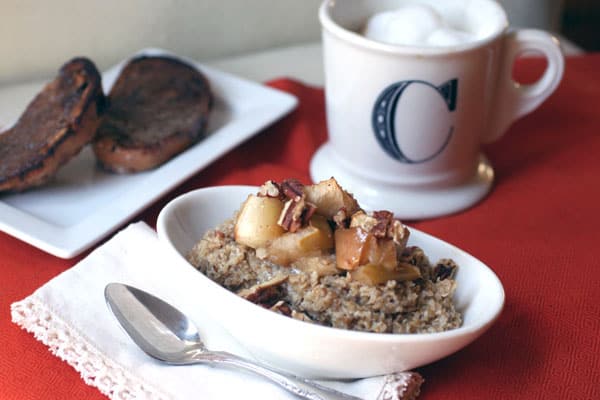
[372,79,458,164]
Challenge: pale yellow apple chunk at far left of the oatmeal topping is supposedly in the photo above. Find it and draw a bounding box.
[234,195,285,249]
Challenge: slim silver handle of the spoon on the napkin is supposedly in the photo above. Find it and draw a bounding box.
[193,351,361,400]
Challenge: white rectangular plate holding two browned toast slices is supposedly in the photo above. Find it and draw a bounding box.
[0,49,297,258]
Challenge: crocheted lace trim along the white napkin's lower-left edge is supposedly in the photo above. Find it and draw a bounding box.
[11,296,169,400]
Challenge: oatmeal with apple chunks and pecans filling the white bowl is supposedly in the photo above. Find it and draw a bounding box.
[189,178,462,333]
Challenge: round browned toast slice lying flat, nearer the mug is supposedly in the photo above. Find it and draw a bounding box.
[93,56,213,173]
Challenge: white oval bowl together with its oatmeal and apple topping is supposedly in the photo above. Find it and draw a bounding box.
[156,182,504,379]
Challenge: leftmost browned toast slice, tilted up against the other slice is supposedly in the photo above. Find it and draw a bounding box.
[0,58,104,192]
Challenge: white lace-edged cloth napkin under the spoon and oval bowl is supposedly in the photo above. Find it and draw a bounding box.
[11,223,421,400]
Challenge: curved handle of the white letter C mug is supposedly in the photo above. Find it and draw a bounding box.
[483,29,565,143]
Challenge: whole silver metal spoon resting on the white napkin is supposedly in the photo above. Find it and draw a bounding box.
[104,283,360,400]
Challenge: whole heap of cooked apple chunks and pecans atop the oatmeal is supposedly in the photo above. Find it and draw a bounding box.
[234,178,420,284]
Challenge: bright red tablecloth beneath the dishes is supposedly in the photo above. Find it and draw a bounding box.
[0,54,600,400]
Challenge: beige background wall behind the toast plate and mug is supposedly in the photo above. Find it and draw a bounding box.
[0,0,562,86]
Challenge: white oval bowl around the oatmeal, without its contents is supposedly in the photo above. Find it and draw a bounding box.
[157,186,504,379]
